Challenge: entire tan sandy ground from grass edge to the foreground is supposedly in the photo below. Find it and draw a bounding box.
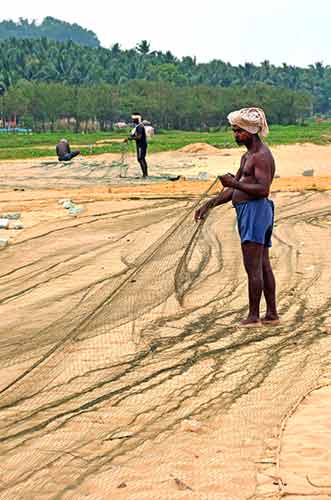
[0,145,331,500]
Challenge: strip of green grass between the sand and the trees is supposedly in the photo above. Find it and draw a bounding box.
[0,122,331,160]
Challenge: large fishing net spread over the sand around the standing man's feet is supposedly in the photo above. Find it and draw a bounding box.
[0,185,331,500]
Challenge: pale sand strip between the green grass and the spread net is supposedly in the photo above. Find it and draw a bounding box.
[0,144,331,189]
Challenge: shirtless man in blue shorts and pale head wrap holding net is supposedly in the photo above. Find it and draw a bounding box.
[195,108,279,327]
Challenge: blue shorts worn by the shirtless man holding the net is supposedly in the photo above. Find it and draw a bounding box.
[234,198,275,247]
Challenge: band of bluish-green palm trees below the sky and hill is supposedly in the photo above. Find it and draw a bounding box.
[0,38,331,113]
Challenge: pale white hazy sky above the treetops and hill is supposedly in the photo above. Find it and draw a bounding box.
[0,0,331,66]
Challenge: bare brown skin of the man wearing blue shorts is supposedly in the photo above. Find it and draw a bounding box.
[195,126,279,326]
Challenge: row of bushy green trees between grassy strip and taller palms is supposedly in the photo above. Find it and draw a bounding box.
[0,80,313,131]
